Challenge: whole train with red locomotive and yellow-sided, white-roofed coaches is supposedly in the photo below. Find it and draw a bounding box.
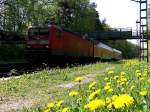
[26,25,122,61]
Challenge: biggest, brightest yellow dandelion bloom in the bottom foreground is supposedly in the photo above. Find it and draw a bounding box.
[113,94,134,109]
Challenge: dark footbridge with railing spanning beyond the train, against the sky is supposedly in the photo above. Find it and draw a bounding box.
[80,28,149,40]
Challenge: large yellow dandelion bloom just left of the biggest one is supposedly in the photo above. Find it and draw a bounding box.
[84,99,105,111]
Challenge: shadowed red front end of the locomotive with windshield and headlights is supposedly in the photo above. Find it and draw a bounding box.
[25,27,50,61]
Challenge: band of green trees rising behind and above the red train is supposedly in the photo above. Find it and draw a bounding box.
[0,0,107,33]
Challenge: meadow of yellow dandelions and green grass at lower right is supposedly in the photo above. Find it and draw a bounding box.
[43,60,150,112]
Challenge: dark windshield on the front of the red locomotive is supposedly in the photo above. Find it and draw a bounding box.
[28,28,49,38]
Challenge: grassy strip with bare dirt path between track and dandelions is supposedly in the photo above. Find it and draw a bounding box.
[0,62,115,111]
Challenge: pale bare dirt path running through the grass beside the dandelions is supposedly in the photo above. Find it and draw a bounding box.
[0,66,114,112]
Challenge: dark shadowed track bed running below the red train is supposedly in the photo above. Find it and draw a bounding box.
[0,58,101,78]
